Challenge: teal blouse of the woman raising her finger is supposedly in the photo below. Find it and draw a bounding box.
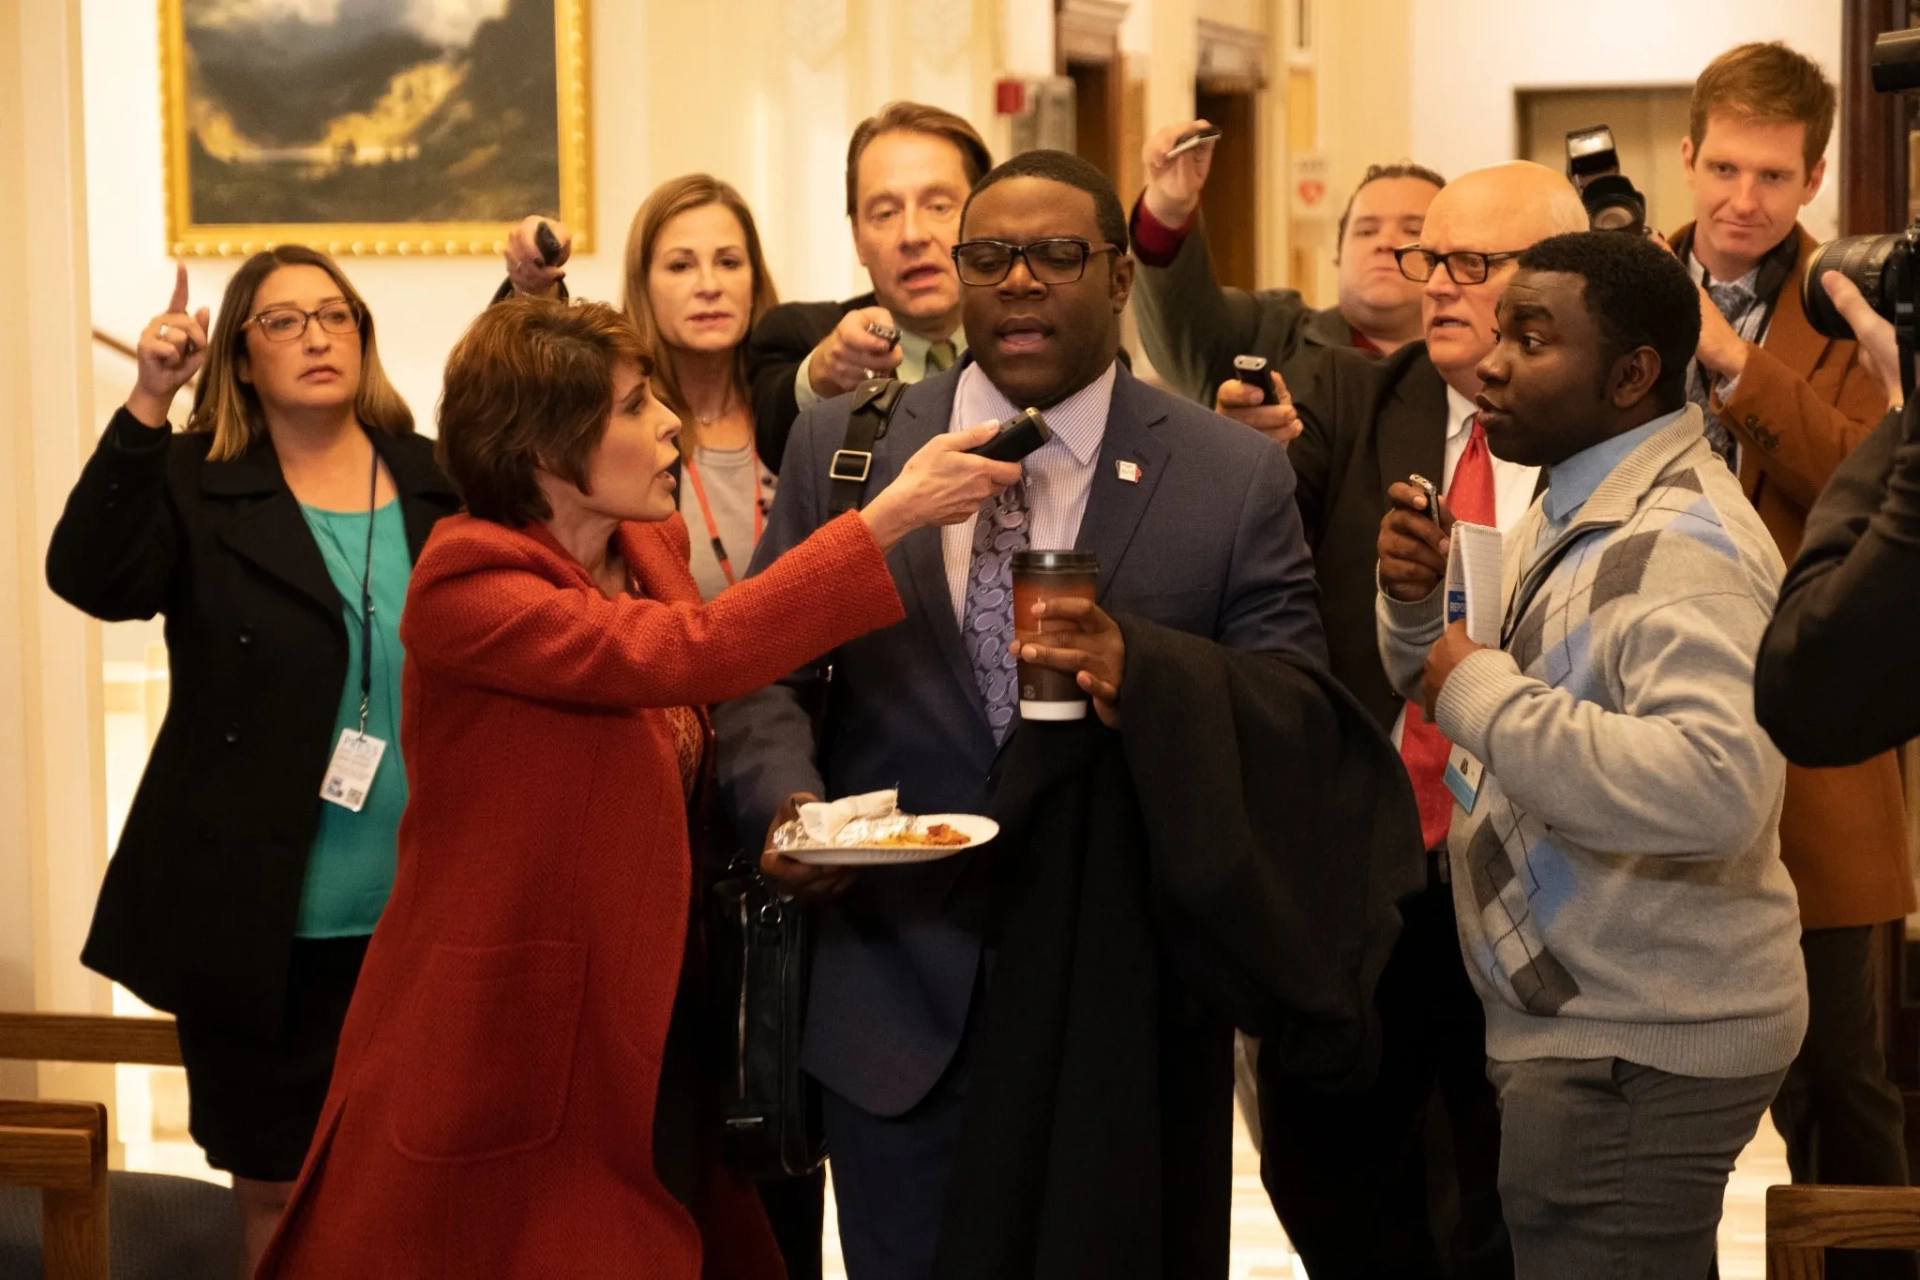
[294,499,413,938]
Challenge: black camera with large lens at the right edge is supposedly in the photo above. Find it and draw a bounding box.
[1801,29,1920,399]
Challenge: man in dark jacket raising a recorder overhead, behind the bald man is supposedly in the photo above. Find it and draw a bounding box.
[1133,121,1446,443]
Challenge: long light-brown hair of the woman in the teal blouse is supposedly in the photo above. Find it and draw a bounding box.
[186,244,413,462]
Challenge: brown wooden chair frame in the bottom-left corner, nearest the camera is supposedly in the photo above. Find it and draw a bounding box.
[0,1100,109,1280]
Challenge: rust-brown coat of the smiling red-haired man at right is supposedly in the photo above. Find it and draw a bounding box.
[1689,226,1914,929]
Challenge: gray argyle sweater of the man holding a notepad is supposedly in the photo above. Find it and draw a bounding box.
[1379,409,1807,1077]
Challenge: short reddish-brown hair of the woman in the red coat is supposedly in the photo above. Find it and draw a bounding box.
[440,297,653,528]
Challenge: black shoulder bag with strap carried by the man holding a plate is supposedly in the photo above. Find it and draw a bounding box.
[707,378,900,1178]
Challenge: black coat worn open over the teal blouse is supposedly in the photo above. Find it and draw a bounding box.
[46,409,459,1036]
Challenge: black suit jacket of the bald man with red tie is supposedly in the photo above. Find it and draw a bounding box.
[1286,342,1448,729]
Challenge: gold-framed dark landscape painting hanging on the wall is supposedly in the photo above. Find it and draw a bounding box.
[159,0,593,257]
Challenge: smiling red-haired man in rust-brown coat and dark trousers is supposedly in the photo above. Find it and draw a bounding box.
[1672,44,1916,1280]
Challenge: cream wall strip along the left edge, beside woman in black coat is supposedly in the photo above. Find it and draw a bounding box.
[0,0,111,1100]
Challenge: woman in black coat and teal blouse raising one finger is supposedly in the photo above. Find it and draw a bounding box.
[46,246,459,1270]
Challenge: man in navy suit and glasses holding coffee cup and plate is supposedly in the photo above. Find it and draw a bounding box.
[718,152,1325,1280]
